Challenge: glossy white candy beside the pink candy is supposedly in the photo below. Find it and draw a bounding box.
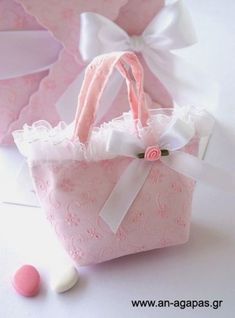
[51,266,79,293]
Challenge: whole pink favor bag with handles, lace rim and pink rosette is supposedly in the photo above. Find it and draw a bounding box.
[14,52,202,265]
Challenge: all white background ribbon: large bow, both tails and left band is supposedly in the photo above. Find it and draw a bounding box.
[0,0,216,123]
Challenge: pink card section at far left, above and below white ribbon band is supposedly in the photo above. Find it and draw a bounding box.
[0,0,48,143]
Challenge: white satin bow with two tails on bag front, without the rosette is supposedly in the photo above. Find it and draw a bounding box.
[99,119,235,233]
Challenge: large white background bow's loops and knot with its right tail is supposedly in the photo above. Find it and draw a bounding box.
[80,0,216,106]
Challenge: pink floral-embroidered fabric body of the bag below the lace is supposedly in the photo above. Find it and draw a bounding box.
[32,148,194,265]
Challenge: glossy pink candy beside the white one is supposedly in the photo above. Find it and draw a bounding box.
[13,265,40,297]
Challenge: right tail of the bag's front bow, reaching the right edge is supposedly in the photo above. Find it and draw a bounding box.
[161,151,235,193]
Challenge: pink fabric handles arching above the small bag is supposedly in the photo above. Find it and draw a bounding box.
[74,52,149,143]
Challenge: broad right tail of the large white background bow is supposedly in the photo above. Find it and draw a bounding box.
[142,46,218,109]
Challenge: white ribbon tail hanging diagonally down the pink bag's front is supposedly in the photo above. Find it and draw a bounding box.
[99,159,152,233]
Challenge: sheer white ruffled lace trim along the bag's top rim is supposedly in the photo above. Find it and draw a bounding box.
[13,107,213,161]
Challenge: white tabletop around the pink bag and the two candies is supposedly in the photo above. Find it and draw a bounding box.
[0,0,235,318]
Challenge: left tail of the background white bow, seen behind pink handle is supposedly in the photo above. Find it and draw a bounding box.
[56,68,123,124]
